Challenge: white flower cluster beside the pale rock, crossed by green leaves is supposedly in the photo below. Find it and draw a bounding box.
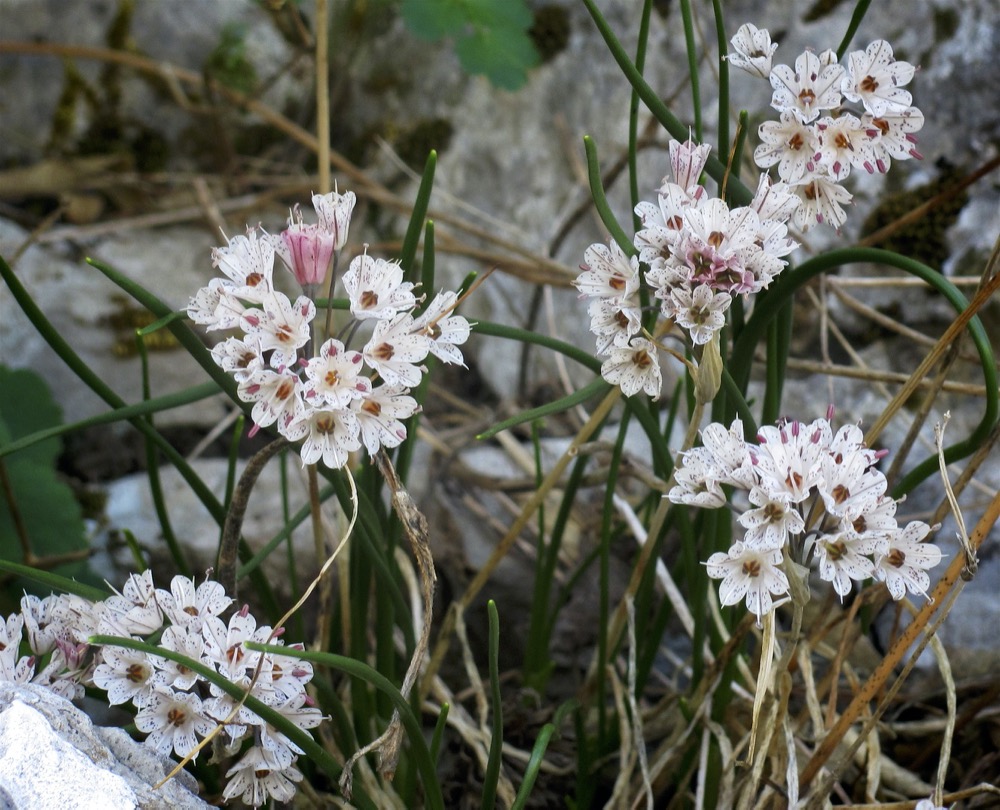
[0,571,323,807]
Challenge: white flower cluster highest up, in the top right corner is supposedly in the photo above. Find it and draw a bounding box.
[728,23,924,230]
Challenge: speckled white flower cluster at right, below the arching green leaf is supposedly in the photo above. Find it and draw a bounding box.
[668,414,941,623]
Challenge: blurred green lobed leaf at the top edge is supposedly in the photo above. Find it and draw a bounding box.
[402,0,539,90]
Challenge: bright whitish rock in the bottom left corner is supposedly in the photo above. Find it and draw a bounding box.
[0,683,208,810]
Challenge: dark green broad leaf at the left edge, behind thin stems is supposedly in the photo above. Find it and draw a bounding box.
[0,366,87,588]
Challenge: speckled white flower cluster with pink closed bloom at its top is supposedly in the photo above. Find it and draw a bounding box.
[187,192,470,468]
